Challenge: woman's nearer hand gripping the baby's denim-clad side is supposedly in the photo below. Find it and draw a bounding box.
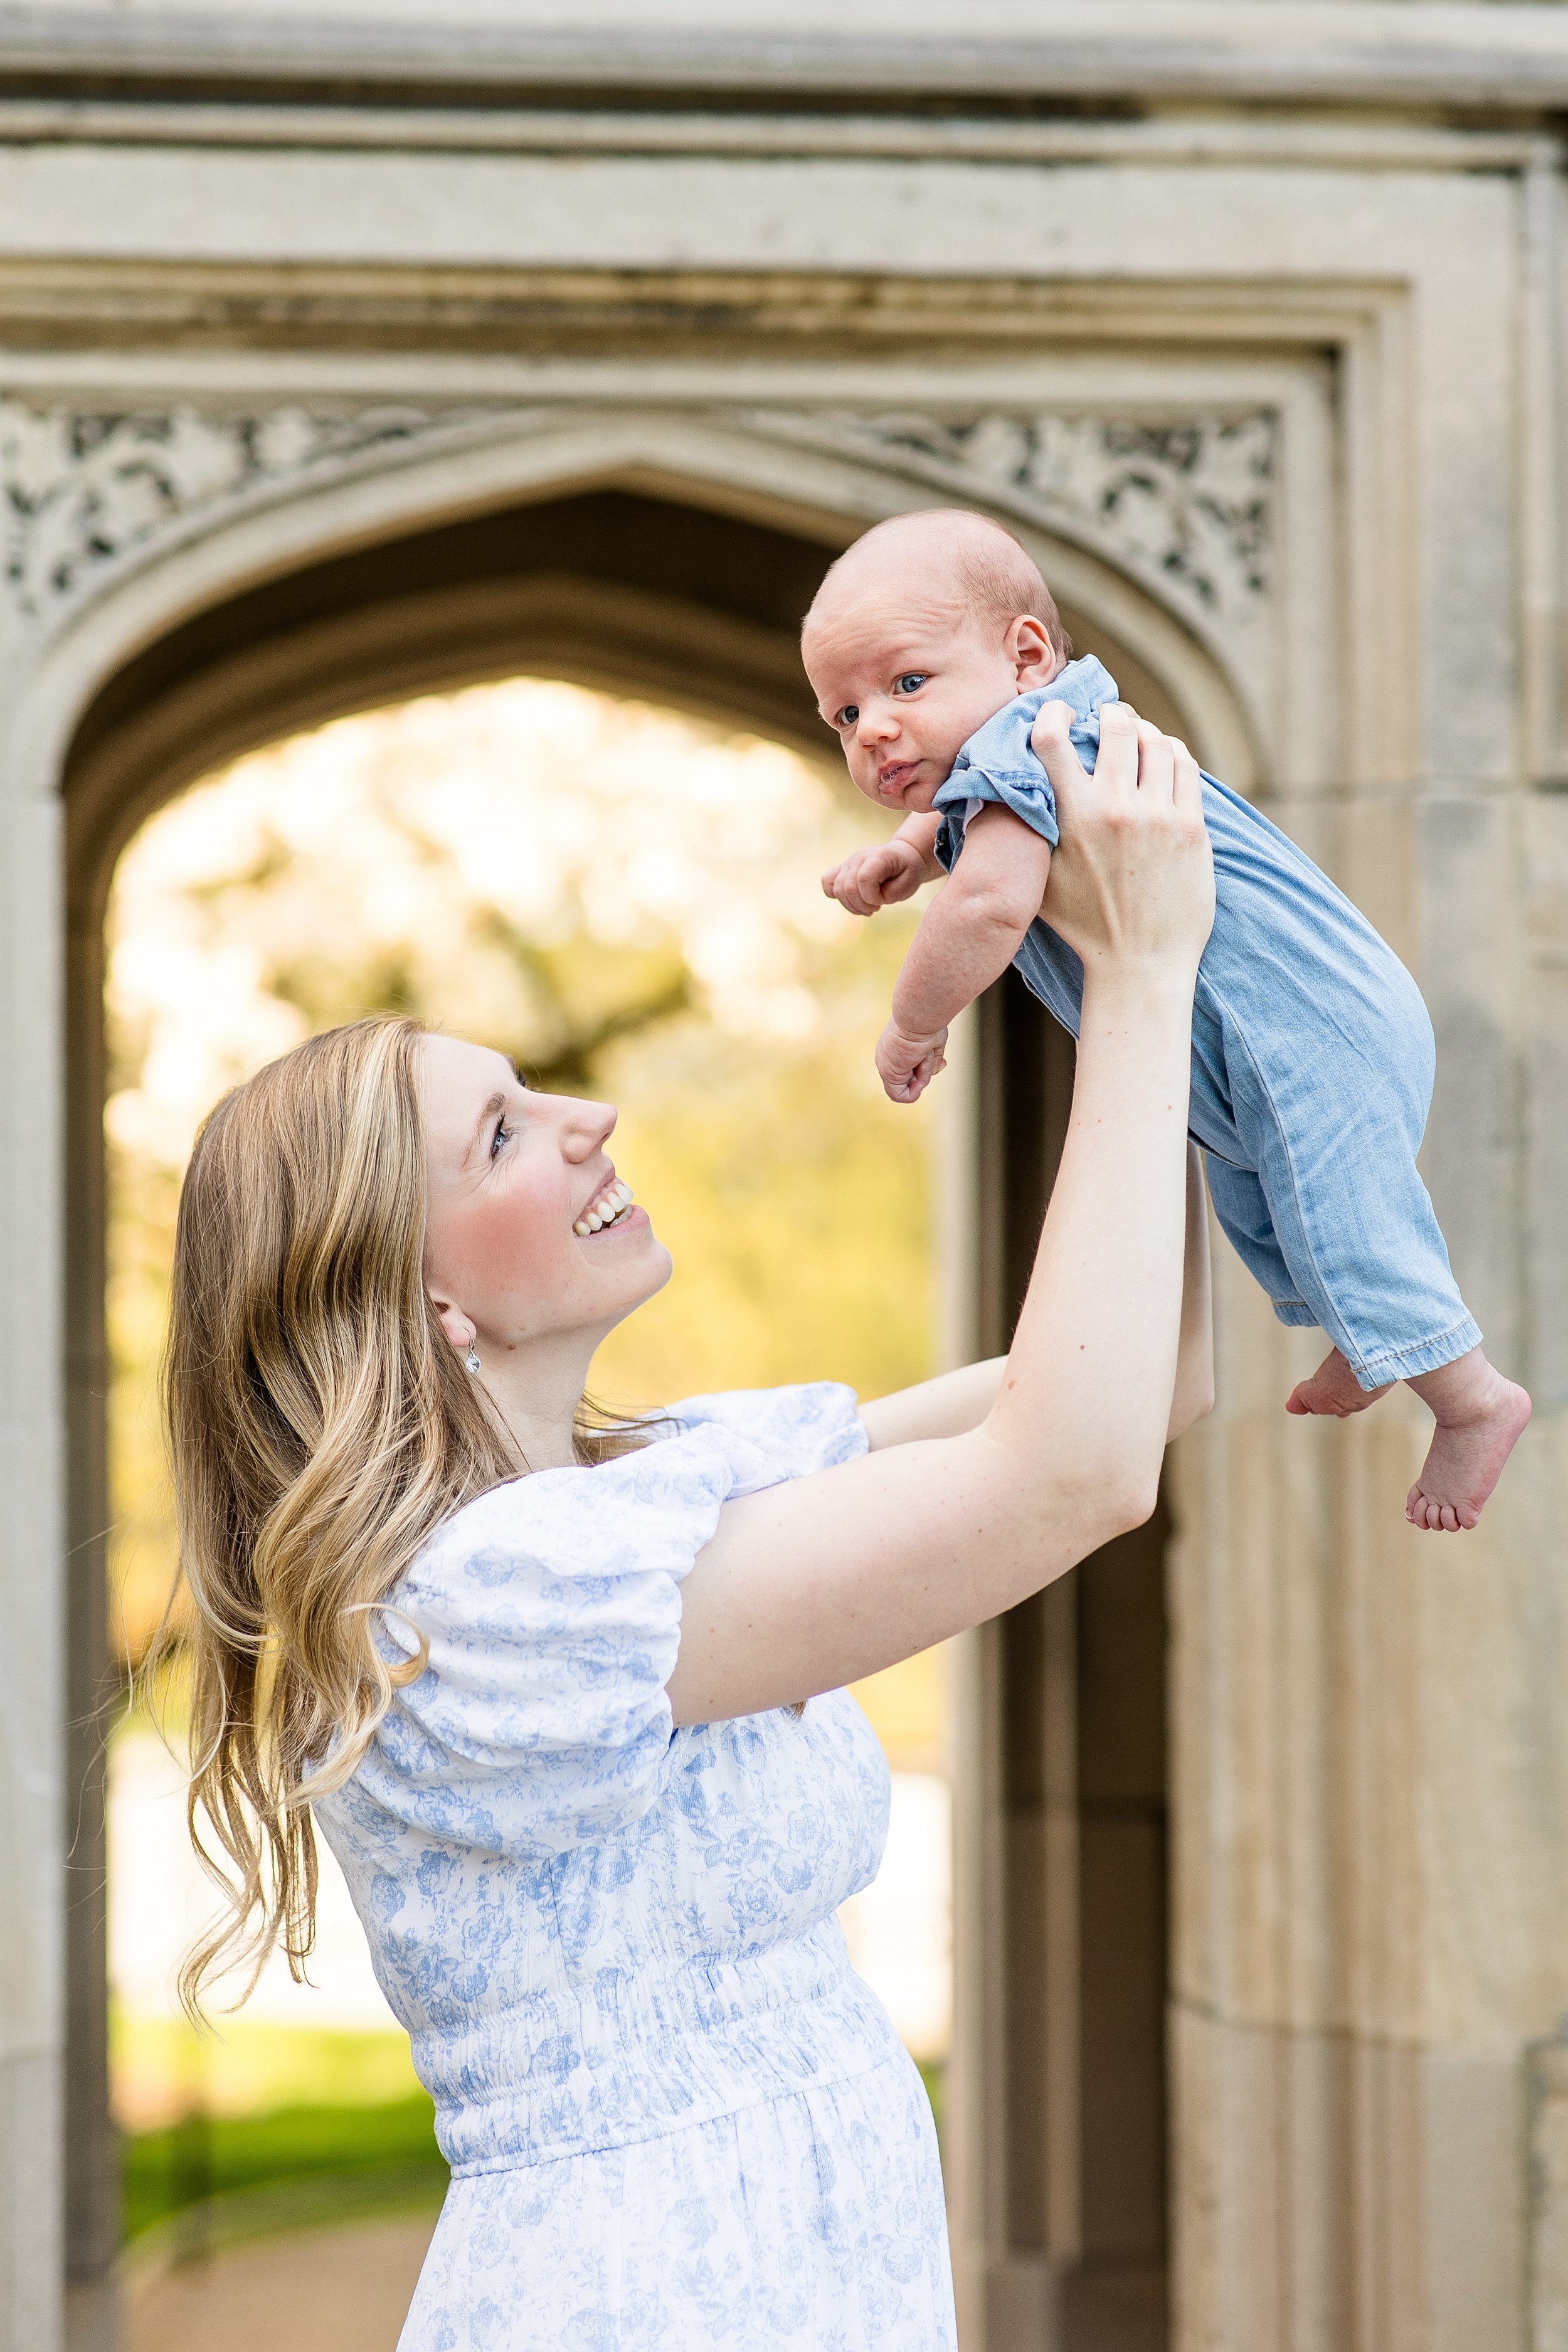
[1034,703,1213,985]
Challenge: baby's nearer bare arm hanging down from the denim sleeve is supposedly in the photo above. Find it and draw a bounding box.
[877,802,1051,1103]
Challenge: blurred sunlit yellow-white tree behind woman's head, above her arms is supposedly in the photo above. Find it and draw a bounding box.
[106,680,931,1661]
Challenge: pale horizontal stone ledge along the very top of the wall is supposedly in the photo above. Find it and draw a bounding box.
[0,0,1568,113]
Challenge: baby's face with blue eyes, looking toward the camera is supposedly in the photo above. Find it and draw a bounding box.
[802,593,1053,812]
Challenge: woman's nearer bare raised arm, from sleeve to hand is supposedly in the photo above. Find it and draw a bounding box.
[670,706,1213,1724]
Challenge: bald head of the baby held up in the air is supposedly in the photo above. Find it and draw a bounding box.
[802,508,1072,809]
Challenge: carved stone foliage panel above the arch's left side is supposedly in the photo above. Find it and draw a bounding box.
[0,400,491,618]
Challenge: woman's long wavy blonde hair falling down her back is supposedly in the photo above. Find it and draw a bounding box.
[162,1016,639,2016]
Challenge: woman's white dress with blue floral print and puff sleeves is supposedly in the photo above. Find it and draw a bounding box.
[315,1383,955,2352]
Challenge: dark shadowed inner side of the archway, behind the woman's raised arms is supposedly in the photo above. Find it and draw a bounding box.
[980,972,1168,2352]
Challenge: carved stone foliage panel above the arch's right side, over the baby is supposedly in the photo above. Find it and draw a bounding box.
[752,410,1279,633]
